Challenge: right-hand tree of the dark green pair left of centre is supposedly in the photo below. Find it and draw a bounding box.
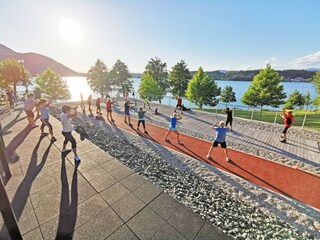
[109,60,132,96]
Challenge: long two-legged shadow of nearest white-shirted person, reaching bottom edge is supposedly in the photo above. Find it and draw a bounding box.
[55,154,78,240]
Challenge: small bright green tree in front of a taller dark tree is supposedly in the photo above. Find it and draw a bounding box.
[139,72,165,100]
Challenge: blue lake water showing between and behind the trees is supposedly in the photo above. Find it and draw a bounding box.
[17,77,317,109]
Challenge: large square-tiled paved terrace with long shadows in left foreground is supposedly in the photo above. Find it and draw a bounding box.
[0,108,230,239]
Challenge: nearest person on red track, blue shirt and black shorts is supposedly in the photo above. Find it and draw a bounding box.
[207,121,230,162]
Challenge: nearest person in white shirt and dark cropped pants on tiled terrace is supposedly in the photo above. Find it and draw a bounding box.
[60,105,80,162]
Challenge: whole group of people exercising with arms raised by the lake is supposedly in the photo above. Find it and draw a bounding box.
[24,93,294,166]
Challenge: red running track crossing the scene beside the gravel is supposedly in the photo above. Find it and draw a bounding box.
[103,111,320,209]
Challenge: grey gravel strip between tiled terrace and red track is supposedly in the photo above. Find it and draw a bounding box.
[52,106,320,239]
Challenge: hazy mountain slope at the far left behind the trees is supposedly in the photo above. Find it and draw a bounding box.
[0,44,83,77]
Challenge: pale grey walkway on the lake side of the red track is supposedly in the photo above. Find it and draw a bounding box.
[118,100,320,166]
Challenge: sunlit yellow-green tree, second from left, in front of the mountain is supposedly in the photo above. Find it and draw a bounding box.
[34,67,70,100]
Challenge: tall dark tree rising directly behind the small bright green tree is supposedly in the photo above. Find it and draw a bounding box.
[144,57,169,103]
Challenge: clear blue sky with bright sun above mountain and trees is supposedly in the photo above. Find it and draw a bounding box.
[0,0,320,72]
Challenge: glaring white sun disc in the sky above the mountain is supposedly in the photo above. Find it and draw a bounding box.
[60,19,83,43]
